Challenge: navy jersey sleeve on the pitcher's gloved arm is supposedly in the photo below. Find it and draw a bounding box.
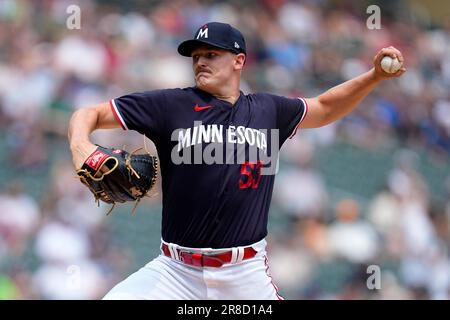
[110,90,167,140]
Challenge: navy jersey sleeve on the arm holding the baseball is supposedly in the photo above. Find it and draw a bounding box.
[271,95,308,145]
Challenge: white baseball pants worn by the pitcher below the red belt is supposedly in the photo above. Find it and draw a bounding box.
[103,239,283,300]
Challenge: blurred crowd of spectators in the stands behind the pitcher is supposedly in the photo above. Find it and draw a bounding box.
[0,0,450,299]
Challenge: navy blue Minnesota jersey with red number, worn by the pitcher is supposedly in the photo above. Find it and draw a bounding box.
[111,87,307,248]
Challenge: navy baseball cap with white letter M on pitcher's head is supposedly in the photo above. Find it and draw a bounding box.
[178,22,247,57]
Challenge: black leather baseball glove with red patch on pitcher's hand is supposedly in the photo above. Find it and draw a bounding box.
[77,146,158,215]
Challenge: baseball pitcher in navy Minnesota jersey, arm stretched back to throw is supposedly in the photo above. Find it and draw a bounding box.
[69,22,406,300]
